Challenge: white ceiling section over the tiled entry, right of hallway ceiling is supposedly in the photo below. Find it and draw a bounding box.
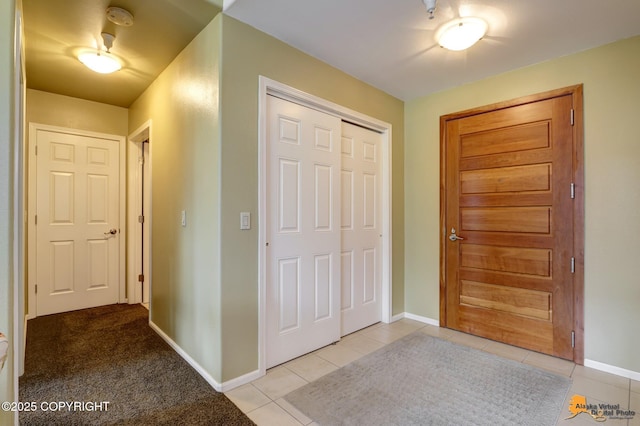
[224,0,640,100]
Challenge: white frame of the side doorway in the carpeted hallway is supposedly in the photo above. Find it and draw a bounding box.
[127,120,153,306]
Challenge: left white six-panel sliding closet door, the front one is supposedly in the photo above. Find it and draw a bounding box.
[266,96,341,368]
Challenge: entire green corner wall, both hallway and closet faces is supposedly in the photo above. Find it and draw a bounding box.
[129,14,404,383]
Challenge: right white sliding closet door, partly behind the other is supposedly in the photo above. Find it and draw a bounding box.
[341,123,382,336]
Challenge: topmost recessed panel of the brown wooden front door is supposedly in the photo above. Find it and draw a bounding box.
[460,121,550,158]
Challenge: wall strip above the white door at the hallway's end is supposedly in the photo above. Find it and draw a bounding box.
[26,89,129,136]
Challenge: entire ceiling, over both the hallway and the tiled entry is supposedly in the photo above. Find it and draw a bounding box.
[23,0,640,107]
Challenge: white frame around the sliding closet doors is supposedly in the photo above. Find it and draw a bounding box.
[258,76,392,375]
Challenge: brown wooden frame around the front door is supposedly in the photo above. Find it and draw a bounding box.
[440,84,584,365]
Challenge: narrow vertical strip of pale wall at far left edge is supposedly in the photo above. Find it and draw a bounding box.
[0,0,17,425]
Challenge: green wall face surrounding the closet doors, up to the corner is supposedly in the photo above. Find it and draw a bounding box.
[221,15,404,381]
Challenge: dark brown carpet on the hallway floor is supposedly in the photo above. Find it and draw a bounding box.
[20,305,254,426]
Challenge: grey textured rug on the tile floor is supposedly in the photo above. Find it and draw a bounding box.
[285,332,571,426]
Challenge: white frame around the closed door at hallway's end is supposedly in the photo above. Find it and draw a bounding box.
[27,123,127,319]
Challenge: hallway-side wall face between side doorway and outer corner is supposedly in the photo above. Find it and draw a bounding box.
[129,16,221,383]
